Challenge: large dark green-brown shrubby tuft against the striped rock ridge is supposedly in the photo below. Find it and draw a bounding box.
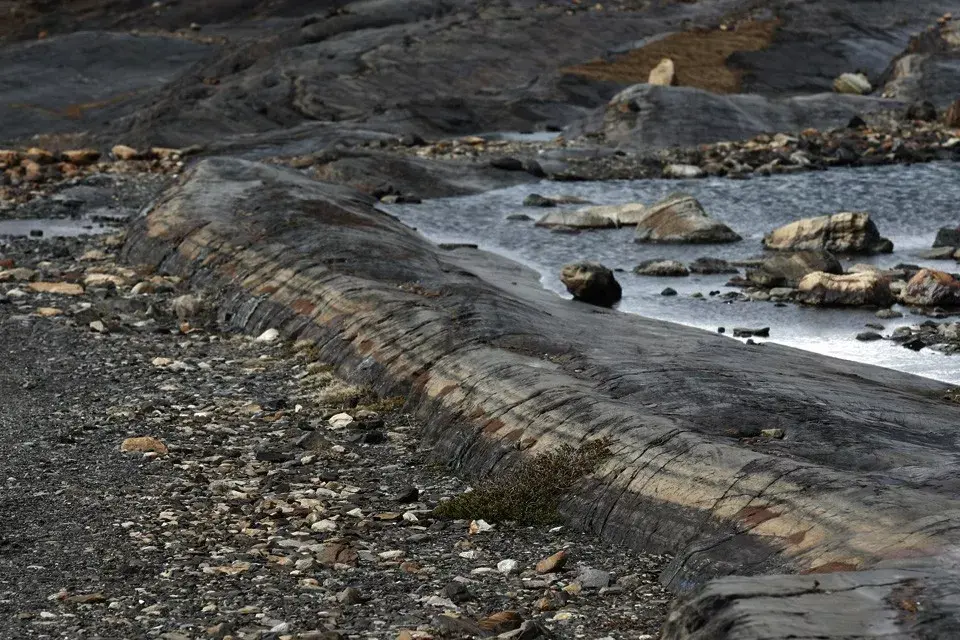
[434,438,612,524]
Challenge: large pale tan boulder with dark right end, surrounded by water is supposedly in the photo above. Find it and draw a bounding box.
[763,211,893,254]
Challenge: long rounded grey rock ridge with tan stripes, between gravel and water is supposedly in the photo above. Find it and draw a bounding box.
[125,159,960,638]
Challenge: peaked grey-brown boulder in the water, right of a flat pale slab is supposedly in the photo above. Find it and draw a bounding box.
[634,194,742,244]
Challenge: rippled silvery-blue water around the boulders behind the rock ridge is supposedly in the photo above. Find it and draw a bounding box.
[383,164,960,383]
